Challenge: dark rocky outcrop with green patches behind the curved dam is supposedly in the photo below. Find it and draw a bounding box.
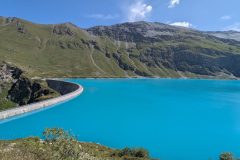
[0,63,59,111]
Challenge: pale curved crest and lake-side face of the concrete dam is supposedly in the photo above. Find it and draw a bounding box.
[0,80,84,120]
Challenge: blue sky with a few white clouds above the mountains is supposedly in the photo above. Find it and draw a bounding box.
[0,0,240,31]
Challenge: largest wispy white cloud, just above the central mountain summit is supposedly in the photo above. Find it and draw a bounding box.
[128,0,153,22]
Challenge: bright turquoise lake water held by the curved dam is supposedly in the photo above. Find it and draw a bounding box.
[0,79,240,160]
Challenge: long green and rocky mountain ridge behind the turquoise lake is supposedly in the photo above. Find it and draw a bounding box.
[0,17,240,78]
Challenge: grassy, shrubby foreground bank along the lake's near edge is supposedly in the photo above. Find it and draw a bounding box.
[0,128,151,160]
